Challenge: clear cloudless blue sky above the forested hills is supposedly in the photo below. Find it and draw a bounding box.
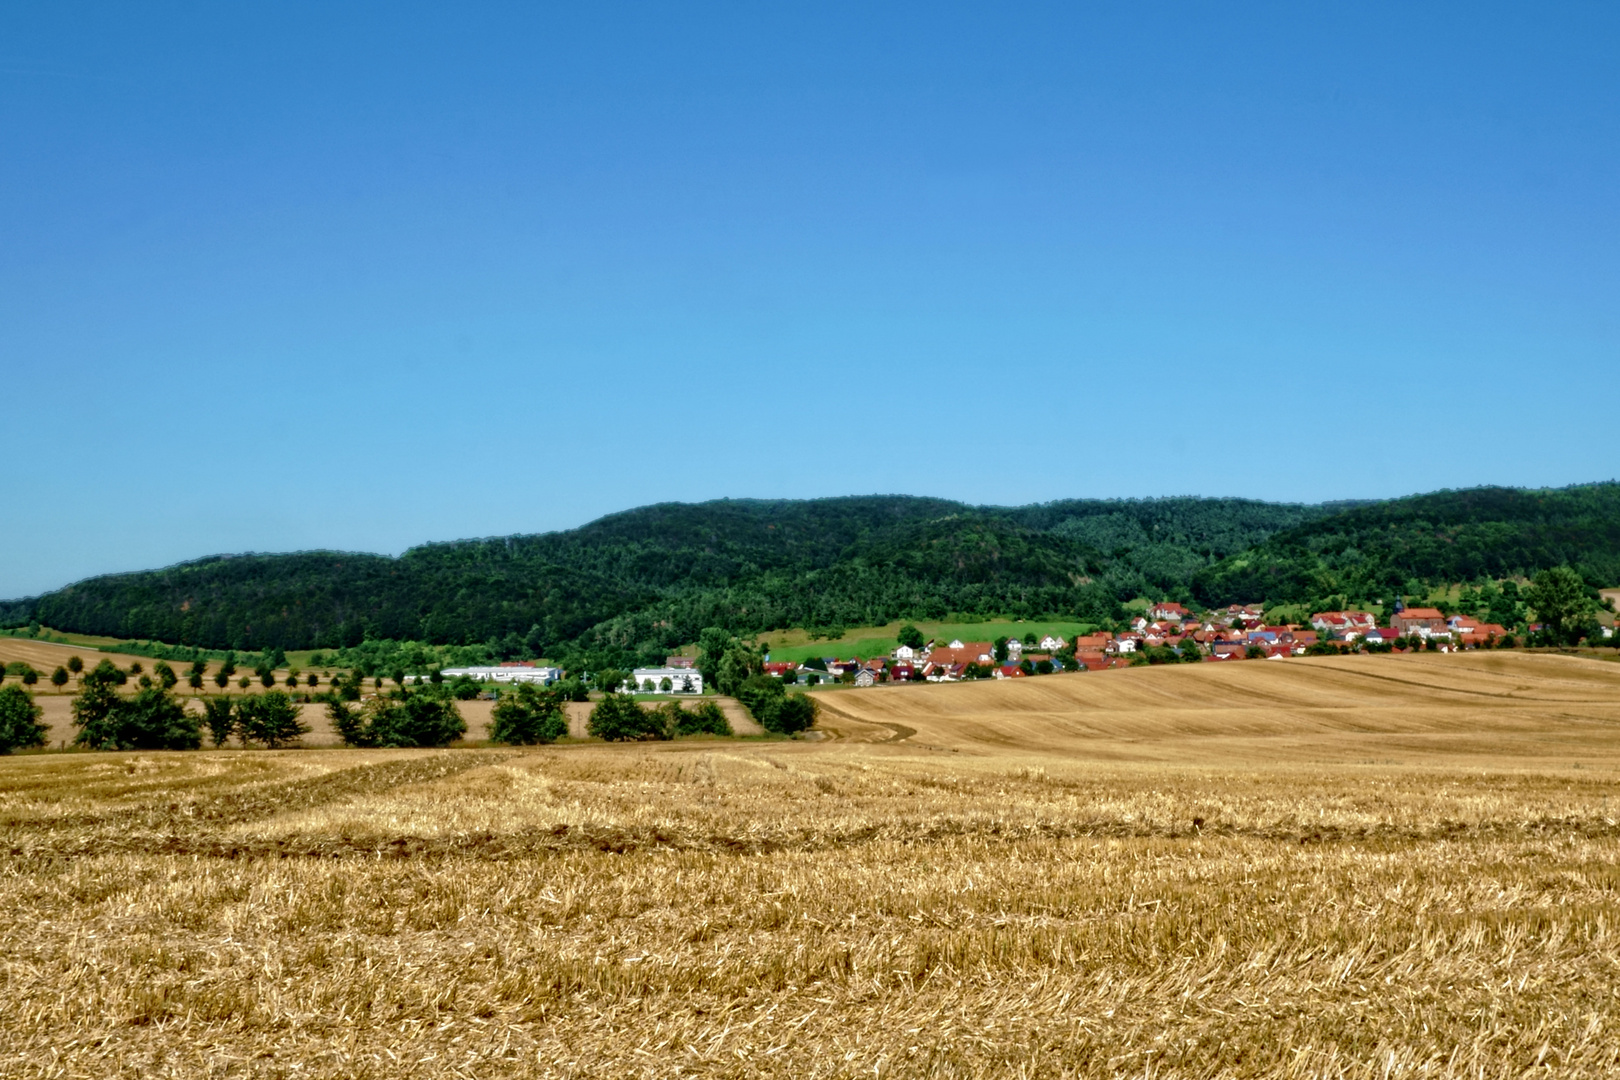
[0,2,1620,596]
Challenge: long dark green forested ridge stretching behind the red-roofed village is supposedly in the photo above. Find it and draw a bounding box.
[3,484,1620,662]
